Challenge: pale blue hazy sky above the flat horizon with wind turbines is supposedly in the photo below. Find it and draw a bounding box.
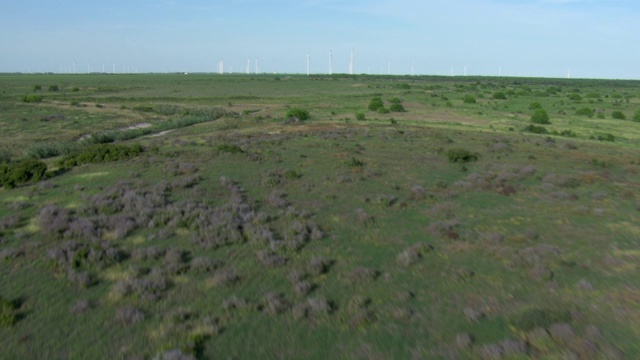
[0,0,640,79]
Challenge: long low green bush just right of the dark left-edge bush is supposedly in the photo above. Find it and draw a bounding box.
[59,144,143,167]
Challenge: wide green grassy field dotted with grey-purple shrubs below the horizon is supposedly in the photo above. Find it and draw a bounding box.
[0,74,640,359]
